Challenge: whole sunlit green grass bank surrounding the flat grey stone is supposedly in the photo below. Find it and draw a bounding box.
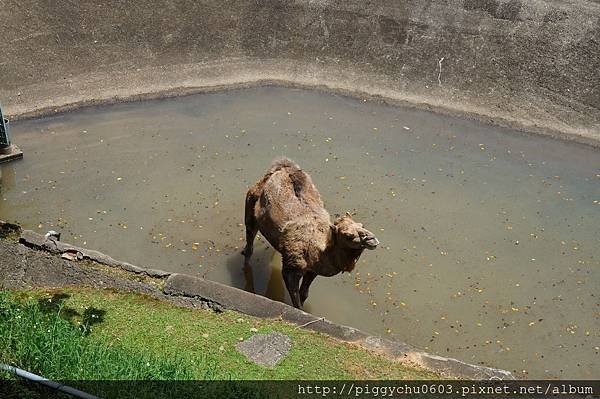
[0,289,436,394]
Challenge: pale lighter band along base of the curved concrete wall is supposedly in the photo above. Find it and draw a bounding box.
[6,67,600,148]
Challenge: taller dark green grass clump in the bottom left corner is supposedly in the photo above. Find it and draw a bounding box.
[0,292,194,380]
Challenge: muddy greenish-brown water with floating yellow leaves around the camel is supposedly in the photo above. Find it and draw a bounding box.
[0,88,600,378]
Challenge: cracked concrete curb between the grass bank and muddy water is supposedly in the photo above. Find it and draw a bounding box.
[11,221,514,379]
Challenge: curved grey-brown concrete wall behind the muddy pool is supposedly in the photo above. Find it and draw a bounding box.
[0,0,600,141]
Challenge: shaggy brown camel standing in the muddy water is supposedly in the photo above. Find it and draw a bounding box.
[242,158,379,309]
